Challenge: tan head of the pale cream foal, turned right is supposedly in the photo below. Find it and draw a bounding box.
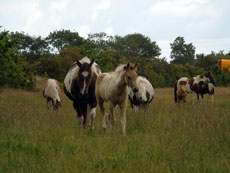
[124,63,138,93]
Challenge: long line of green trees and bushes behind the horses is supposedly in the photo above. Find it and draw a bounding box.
[0,28,230,89]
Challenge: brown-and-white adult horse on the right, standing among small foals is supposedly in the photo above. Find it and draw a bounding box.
[174,72,215,103]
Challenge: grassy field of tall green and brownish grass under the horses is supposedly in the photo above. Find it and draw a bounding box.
[0,79,230,172]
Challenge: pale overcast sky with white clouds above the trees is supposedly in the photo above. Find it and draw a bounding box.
[0,0,230,59]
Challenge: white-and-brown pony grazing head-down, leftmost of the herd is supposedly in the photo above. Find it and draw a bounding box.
[42,79,61,112]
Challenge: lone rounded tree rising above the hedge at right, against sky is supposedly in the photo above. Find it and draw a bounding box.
[170,37,196,64]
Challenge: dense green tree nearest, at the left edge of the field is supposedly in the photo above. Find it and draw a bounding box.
[0,28,34,89]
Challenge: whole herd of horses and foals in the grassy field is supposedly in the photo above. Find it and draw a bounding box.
[43,57,215,134]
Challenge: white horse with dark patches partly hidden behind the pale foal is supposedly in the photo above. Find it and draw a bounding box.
[128,76,154,109]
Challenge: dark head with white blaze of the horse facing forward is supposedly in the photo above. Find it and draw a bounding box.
[77,60,94,97]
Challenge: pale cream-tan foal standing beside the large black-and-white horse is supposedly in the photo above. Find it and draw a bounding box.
[96,63,138,134]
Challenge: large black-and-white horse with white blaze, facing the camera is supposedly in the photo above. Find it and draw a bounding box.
[64,57,101,129]
